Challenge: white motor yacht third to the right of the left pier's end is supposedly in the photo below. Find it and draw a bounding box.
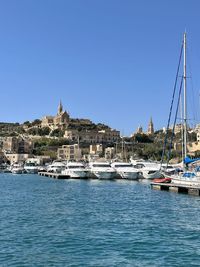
[111,162,140,180]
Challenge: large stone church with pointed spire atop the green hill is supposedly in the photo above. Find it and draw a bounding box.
[41,101,69,129]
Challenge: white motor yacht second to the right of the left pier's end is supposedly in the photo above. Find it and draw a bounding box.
[89,161,117,179]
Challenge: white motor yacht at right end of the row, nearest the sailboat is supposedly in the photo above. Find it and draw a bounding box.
[132,160,163,179]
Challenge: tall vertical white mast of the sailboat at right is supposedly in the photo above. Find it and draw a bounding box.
[183,32,187,157]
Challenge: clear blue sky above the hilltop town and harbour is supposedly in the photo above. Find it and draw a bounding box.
[0,0,200,135]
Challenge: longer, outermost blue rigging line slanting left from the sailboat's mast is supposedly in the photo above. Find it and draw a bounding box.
[160,43,183,169]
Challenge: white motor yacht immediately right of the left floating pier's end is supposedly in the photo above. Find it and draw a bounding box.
[61,162,89,178]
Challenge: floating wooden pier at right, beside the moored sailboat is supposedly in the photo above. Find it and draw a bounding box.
[151,183,200,196]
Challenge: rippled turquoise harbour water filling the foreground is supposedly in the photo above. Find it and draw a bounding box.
[0,174,200,267]
